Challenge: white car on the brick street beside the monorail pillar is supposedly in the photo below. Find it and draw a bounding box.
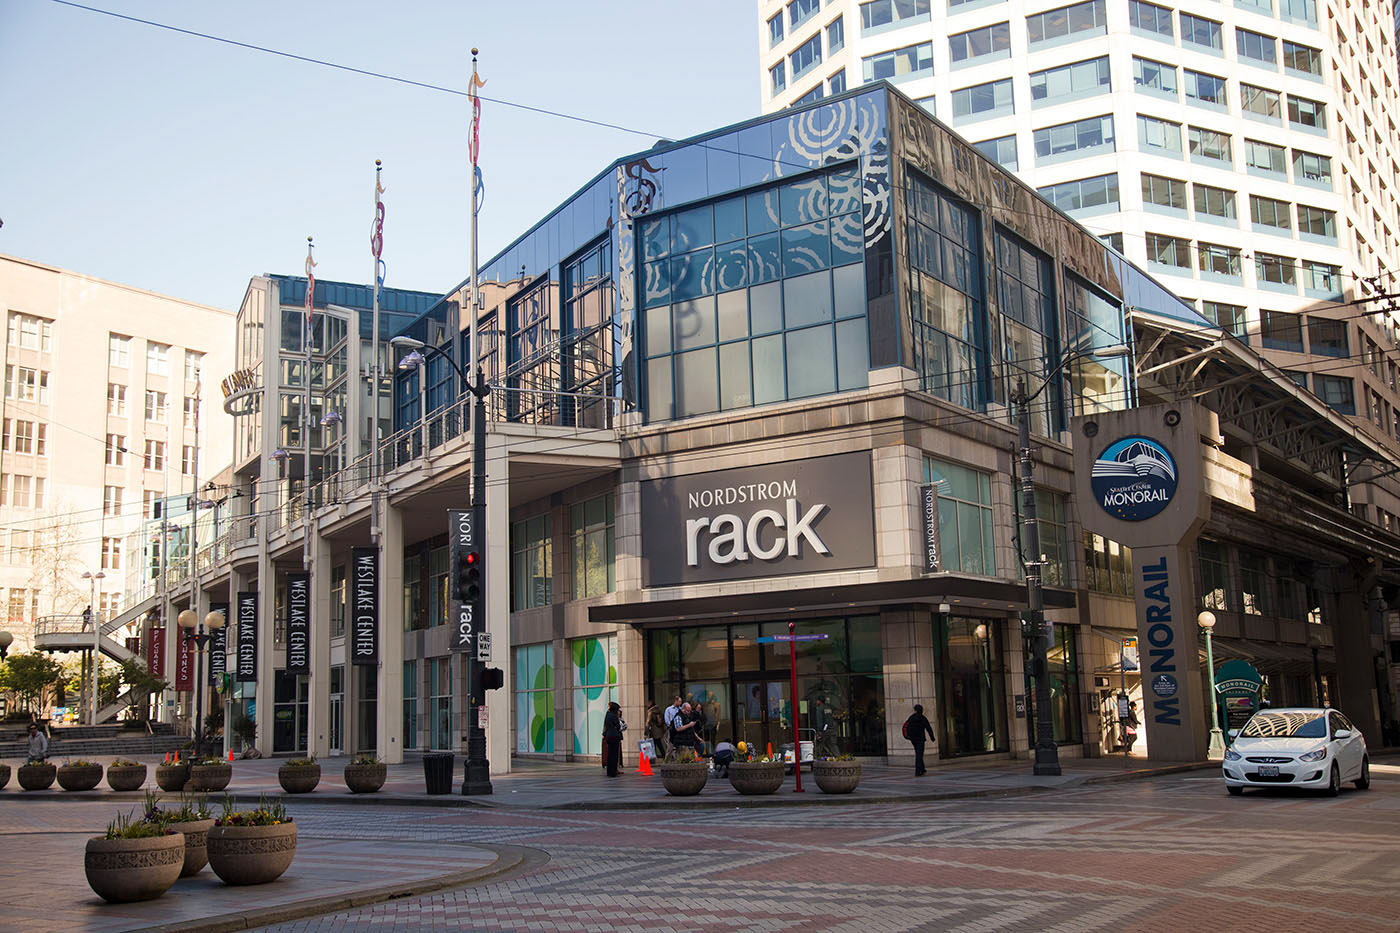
[1221,709,1371,797]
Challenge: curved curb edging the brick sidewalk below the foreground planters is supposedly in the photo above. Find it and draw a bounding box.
[140,845,549,933]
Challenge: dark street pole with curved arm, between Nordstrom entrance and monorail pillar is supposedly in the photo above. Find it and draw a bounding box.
[1011,345,1128,775]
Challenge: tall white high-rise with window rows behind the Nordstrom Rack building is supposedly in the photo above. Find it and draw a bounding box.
[757,0,1400,515]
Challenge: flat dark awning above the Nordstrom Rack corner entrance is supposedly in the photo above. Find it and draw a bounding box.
[588,574,1075,623]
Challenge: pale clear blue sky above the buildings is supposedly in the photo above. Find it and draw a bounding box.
[0,0,760,308]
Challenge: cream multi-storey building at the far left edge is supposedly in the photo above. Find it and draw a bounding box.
[0,255,234,650]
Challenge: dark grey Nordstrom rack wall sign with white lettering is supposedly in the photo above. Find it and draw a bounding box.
[641,451,875,586]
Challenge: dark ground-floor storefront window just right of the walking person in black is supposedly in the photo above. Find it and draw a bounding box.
[934,615,1008,758]
